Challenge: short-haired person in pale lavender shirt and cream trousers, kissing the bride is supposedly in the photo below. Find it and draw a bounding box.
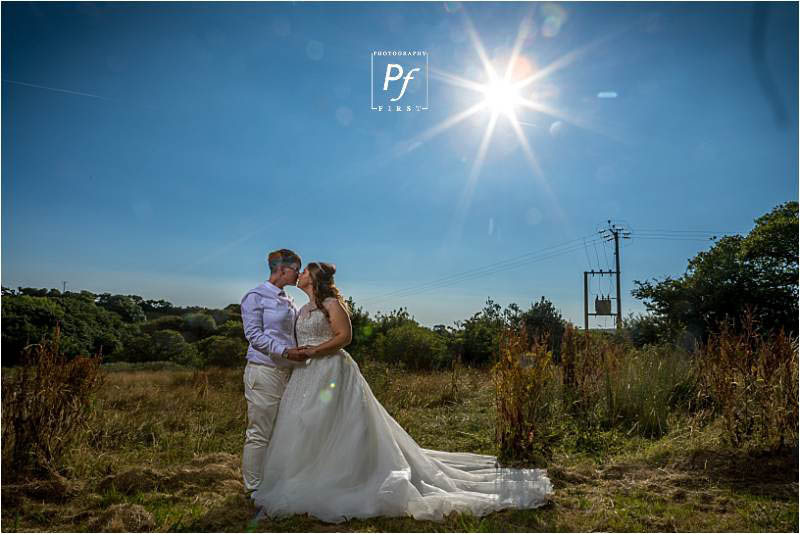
[242,249,304,494]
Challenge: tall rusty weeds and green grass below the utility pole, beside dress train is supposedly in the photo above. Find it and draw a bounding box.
[493,326,693,462]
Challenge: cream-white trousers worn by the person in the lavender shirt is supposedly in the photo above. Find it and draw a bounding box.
[242,363,291,491]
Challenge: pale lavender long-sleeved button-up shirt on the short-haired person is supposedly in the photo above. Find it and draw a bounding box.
[242,281,297,367]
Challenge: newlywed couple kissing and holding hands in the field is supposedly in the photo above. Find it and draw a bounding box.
[242,249,552,523]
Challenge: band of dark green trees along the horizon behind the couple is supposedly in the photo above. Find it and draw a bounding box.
[2,201,798,369]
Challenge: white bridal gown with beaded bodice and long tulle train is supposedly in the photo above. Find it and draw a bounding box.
[253,304,553,523]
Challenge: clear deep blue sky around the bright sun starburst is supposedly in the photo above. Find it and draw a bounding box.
[2,2,798,326]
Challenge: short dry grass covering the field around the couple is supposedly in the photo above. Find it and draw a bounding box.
[2,365,798,532]
